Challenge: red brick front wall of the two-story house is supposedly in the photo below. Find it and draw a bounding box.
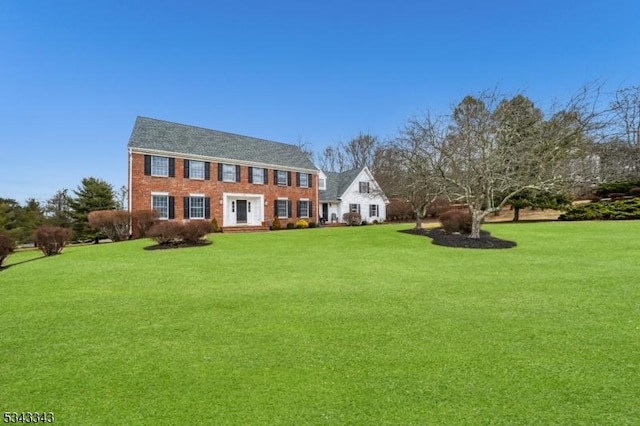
[129,153,318,226]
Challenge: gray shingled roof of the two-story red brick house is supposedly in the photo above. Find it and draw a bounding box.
[129,117,316,170]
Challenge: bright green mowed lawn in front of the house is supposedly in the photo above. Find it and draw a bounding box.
[0,222,640,425]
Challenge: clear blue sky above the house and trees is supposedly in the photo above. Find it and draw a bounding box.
[0,0,640,202]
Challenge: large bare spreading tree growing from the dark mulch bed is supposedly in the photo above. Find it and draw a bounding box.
[400,87,596,238]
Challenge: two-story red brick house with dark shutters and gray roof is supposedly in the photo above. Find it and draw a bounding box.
[128,117,318,230]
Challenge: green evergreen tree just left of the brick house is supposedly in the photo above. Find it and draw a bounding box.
[69,177,116,240]
